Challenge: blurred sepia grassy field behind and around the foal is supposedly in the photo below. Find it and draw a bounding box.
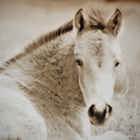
[0,0,140,140]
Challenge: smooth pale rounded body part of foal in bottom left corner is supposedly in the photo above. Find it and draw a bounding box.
[0,87,47,140]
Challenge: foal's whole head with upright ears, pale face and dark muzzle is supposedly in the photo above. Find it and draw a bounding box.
[73,9,122,125]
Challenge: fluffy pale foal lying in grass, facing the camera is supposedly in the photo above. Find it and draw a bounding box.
[0,9,128,140]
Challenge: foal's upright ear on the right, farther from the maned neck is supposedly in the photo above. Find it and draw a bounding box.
[109,9,122,35]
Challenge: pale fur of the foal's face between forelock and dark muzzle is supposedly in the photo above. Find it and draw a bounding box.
[75,31,121,108]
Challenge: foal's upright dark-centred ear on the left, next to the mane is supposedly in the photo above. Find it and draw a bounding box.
[74,9,89,32]
